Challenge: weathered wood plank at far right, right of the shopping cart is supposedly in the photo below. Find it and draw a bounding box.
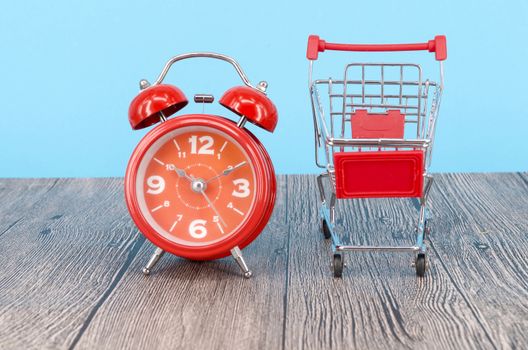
[432,174,528,349]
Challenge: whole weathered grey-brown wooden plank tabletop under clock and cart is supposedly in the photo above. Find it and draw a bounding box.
[0,173,528,349]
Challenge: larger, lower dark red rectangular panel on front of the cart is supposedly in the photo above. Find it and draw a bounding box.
[334,151,424,198]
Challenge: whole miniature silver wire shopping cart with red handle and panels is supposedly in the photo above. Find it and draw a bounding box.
[306,35,447,277]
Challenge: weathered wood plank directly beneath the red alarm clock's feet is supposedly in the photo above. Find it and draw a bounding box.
[72,177,288,349]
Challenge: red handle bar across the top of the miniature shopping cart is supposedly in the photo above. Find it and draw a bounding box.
[306,35,447,61]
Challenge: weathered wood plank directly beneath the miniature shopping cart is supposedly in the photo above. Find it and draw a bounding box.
[285,177,504,349]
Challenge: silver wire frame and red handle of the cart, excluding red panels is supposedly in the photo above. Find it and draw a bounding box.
[307,35,447,277]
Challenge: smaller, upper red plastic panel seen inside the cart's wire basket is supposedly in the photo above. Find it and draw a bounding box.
[352,109,405,139]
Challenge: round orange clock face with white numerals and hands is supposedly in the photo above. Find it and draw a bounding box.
[136,126,257,246]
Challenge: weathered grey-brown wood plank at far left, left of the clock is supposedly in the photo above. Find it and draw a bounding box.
[0,179,142,349]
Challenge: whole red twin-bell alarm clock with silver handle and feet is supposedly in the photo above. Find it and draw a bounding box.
[125,53,278,278]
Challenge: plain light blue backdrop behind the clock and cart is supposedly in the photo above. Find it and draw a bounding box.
[0,0,528,177]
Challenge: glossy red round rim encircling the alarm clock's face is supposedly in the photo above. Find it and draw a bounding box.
[125,114,276,260]
